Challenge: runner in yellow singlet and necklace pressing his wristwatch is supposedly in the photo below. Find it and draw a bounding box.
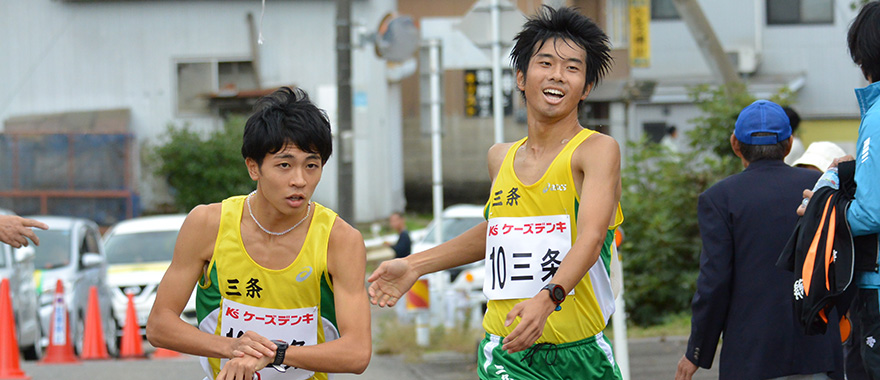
[147,87,371,380]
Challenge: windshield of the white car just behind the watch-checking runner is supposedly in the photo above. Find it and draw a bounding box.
[104,231,178,264]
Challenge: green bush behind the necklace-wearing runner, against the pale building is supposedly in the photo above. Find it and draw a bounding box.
[149,116,255,212]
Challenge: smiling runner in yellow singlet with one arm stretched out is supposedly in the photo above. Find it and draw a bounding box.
[369,7,623,380]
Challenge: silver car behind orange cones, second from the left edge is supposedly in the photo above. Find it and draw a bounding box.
[29,215,119,356]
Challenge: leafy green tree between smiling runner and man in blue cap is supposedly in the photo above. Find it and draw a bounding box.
[621,84,791,326]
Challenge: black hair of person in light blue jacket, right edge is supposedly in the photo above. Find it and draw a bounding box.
[846,1,880,82]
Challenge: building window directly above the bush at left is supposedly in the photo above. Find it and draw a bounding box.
[177,60,257,115]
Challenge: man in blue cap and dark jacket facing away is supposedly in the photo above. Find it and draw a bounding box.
[675,100,843,380]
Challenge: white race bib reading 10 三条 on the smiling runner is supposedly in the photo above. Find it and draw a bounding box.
[483,215,573,300]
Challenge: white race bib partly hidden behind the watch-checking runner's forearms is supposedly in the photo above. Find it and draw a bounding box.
[220,299,321,380]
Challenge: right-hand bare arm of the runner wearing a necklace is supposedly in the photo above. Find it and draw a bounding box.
[284,218,372,373]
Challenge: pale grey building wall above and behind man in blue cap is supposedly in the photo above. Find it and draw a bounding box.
[631,0,867,151]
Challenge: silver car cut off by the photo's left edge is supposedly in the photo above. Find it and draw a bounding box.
[0,209,43,360]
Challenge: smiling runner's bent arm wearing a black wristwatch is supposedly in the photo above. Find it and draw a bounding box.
[502,134,620,353]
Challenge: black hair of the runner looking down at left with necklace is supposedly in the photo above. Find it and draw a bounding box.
[241,87,333,165]
